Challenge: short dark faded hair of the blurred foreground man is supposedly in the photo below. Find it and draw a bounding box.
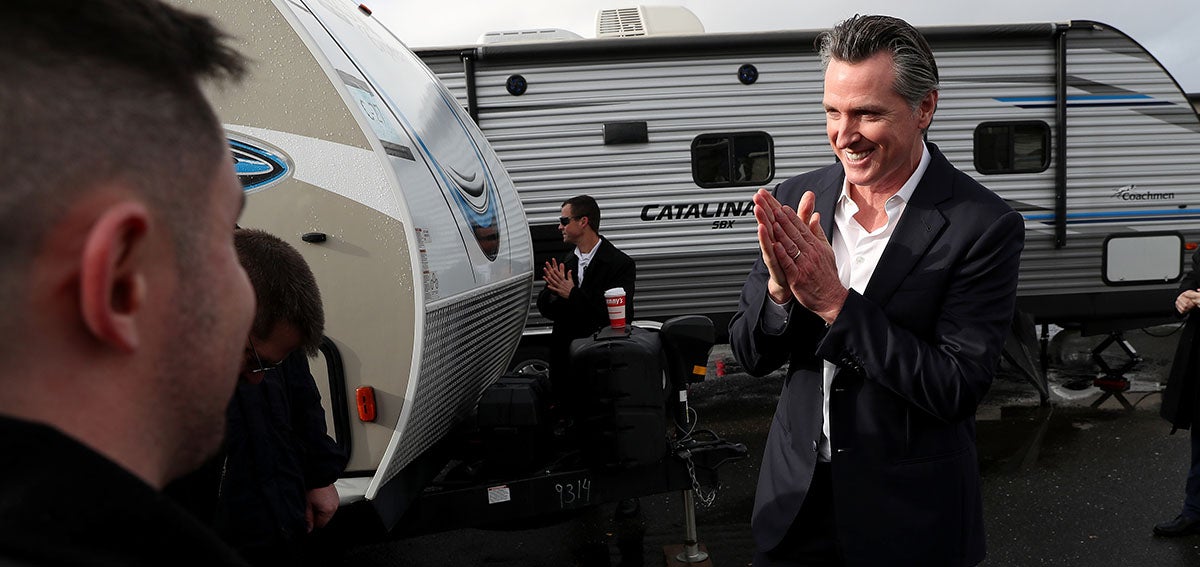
[0,0,245,335]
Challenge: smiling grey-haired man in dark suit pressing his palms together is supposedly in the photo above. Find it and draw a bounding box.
[730,16,1024,566]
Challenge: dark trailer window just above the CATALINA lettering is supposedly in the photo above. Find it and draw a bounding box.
[691,132,775,187]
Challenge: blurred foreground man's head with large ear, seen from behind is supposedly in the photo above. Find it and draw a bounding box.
[0,0,253,484]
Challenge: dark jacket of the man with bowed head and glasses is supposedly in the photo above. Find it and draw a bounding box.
[168,352,346,563]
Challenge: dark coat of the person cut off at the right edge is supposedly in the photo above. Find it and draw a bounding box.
[1159,250,1200,432]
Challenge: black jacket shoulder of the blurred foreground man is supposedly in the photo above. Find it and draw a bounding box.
[0,416,246,567]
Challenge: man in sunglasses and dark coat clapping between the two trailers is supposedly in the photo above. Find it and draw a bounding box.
[538,195,637,413]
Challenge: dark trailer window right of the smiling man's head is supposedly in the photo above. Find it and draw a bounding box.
[974,121,1050,175]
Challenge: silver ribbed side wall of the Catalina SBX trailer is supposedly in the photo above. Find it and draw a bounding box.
[418,22,1200,341]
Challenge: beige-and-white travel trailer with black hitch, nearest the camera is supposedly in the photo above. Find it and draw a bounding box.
[172,0,746,542]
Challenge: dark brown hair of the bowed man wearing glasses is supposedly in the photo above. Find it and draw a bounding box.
[233,228,325,357]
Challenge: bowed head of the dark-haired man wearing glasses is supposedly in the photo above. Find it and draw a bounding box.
[234,228,325,382]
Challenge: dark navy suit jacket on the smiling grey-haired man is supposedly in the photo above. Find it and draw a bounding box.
[730,144,1025,566]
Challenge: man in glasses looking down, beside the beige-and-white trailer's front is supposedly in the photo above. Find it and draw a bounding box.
[169,228,346,565]
